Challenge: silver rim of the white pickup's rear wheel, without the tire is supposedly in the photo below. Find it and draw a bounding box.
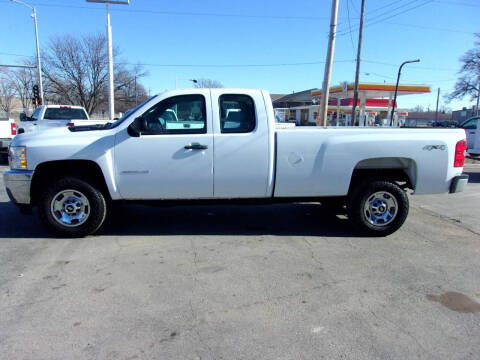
[363,191,398,226]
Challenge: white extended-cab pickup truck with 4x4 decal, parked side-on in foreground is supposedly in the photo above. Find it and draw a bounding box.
[4,89,468,236]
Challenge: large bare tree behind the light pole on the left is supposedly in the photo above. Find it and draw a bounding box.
[43,34,143,113]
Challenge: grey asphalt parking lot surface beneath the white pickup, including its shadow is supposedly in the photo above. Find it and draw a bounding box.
[0,165,480,360]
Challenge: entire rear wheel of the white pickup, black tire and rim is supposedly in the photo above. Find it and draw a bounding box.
[347,180,409,236]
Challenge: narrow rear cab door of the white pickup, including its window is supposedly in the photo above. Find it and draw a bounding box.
[211,89,273,198]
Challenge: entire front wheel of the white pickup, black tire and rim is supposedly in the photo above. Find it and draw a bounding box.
[38,177,107,237]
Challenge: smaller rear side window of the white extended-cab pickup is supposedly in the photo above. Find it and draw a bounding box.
[219,94,256,134]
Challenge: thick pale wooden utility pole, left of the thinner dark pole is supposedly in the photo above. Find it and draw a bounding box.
[317,0,338,126]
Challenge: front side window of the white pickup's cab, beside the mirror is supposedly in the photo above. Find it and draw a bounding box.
[142,95,207,135]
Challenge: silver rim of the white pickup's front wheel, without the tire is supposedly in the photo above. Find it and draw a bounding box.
[50,190,90,227]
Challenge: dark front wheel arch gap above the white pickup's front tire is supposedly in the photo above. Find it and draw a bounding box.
[30,160,111,205]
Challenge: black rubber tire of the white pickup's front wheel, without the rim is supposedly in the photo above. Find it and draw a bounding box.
[38,177,107,237]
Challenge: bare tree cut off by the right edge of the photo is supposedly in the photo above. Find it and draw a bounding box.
[446,33,480,107]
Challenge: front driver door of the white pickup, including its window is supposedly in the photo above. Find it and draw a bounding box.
[115,89,213,200]
